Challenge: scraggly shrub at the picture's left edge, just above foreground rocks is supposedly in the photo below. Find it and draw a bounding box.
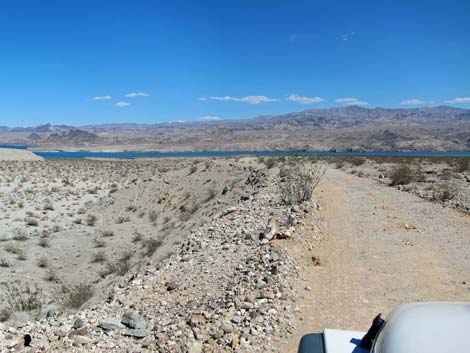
[0,283,43,321]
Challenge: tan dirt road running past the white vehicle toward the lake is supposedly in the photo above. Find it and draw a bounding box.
[280,169,470,352]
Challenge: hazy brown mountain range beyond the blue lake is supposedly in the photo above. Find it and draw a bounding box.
[0,106,470,150]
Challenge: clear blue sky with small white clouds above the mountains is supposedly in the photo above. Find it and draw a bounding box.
[0,0,470,126]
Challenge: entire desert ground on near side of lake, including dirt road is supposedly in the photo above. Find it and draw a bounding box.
[0,150,470,353]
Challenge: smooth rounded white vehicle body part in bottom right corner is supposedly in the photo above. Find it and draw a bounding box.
[373,302,470,353]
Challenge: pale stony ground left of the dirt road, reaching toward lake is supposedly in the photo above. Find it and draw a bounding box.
[0,158,324,352]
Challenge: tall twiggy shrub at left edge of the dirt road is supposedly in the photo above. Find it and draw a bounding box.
[279,164,325,205]
